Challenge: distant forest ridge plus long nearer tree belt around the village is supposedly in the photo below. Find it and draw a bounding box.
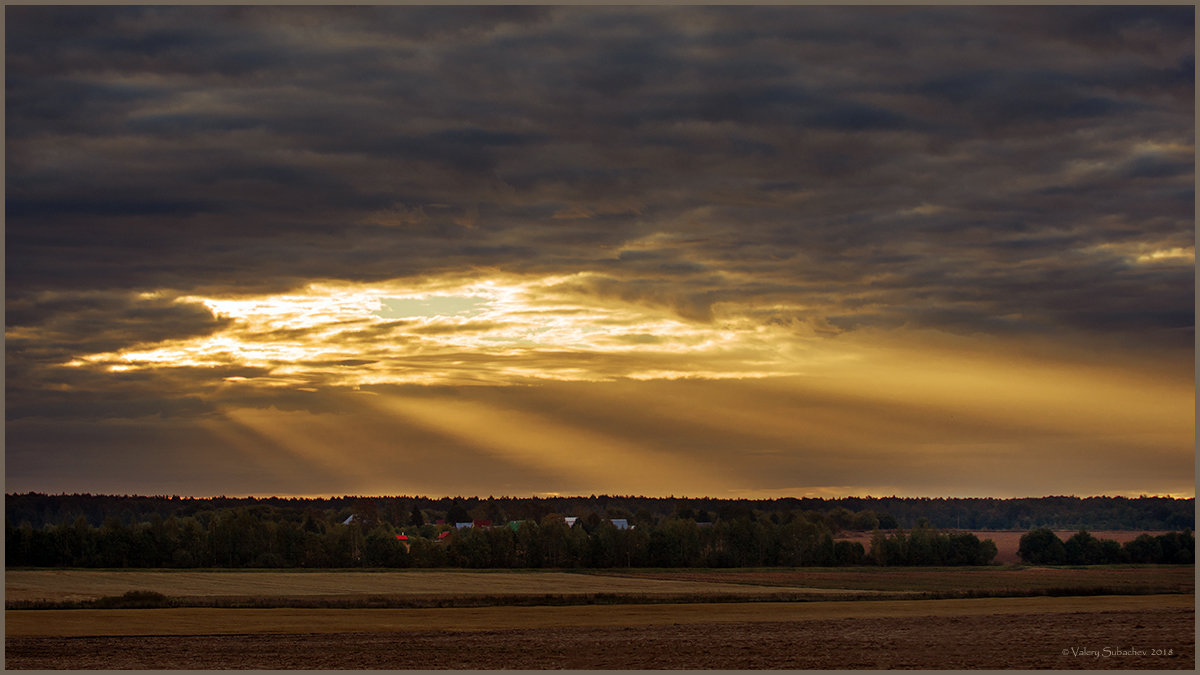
[5,494,1193,568]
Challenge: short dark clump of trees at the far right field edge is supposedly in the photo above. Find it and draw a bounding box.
[1018,527,1196,565]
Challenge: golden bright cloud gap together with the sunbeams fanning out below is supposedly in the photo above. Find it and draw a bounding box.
[44,270,1194,497]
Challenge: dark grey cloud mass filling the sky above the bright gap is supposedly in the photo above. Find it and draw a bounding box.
[6,6,1194,415]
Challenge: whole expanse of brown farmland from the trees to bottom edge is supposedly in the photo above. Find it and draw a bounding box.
[5,567,1195,669]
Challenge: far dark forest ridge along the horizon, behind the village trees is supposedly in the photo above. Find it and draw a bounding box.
[5,492,1195,531]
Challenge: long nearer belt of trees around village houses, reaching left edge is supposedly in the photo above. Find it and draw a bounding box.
[5,506,996,568]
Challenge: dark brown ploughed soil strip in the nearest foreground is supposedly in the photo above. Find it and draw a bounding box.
[6,608,1195,670]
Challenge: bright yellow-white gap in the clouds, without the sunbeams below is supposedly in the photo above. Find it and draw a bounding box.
[66,275,816,387]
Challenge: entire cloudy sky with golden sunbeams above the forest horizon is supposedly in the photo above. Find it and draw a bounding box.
[5,6,1195,498]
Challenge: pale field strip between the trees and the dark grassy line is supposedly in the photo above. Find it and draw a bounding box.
[5,566,1195,609]
